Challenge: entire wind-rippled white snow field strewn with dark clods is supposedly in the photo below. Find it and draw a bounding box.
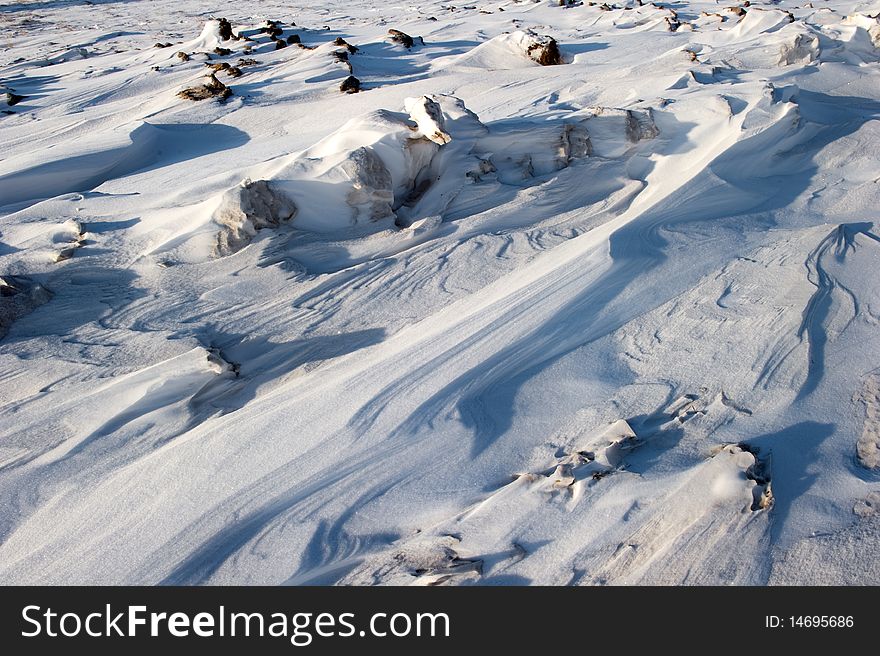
[0,0,880,585]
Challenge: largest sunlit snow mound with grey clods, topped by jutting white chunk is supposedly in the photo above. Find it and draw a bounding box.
[203,96,458,249]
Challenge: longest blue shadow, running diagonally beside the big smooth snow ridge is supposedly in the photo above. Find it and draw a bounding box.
[353,90,880,456]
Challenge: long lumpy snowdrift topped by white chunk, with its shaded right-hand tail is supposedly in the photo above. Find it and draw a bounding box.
[214,95,659,255]
